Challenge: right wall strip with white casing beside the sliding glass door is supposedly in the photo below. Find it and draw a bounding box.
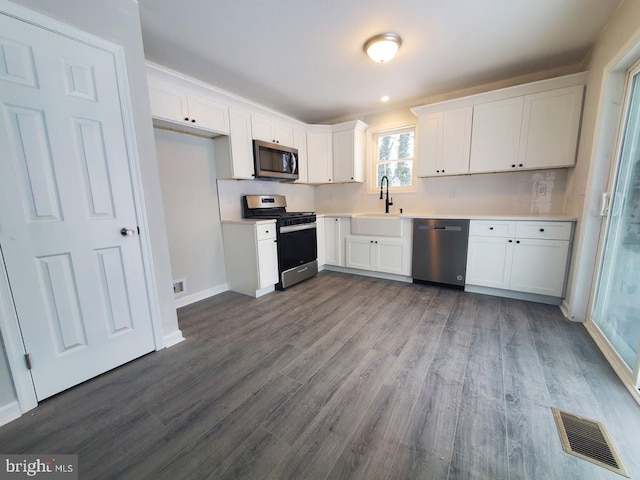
[564,0,640,321]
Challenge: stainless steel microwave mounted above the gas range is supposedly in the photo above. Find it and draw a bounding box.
[253,140,298,182]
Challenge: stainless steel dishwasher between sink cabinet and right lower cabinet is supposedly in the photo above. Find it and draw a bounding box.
[412,219,469,287]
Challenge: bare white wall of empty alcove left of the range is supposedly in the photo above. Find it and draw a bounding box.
[155,129,227,302]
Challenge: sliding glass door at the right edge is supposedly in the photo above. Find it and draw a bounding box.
[591,65,640,387]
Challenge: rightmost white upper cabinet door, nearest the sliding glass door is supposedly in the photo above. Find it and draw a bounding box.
[518,85,584,168]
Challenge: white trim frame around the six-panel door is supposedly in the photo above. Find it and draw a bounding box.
[0,0,165,416]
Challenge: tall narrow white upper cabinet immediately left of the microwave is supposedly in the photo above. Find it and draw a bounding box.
[213,107,255,180]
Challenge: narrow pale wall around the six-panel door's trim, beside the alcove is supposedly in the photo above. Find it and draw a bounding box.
[8,0,179,337]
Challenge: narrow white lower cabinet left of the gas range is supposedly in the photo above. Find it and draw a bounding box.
[222,221,278,297]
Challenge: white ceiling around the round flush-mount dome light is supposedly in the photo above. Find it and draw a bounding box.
[139,0,621,123]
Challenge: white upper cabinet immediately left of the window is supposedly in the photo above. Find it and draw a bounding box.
[332,120,367,183]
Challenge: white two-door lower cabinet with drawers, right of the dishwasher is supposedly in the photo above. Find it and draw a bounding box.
[466,220,573,297]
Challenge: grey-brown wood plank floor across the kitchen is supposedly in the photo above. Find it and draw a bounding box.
[0,272,640,480]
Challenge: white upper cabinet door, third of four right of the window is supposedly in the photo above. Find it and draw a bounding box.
[469,97,523,173]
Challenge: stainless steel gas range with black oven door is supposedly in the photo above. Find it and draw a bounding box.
[242,195,318,290]
